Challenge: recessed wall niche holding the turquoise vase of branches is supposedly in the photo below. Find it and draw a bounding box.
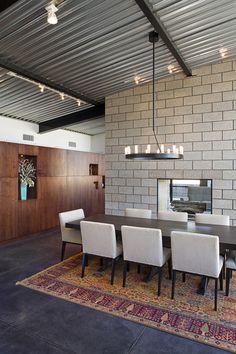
[18,154,37,201]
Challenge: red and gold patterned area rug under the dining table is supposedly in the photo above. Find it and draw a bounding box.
[17,254,236,353]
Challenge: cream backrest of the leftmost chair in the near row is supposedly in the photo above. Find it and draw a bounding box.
[80,221,116,258]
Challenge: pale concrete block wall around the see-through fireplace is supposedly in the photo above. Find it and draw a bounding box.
[105,60,236,225]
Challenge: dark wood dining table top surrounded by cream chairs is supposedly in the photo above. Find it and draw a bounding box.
[65,214,236,251]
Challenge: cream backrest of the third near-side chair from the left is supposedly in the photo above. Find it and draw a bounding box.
[171,231,220,277]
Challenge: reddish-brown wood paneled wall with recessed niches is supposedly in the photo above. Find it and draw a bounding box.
[0,142,105,242]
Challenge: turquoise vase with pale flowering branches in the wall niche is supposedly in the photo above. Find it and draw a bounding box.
[18,158,36,200]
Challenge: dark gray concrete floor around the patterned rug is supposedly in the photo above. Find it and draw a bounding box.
[0,232,231,354]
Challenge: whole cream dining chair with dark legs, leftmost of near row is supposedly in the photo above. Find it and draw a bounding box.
[80,221,122,285]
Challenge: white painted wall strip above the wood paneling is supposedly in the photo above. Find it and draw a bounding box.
[0,116,98,152]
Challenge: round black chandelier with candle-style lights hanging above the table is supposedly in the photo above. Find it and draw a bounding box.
[125,31,184,160]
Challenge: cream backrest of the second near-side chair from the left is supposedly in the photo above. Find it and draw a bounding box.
[121,226,163,267]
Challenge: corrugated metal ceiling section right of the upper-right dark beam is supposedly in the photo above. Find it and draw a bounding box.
[149,0,236,68]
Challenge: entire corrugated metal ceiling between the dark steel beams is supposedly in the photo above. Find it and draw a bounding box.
[0,0,236,134]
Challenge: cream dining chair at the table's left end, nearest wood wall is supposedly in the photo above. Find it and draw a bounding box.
[59,209,84,261]
